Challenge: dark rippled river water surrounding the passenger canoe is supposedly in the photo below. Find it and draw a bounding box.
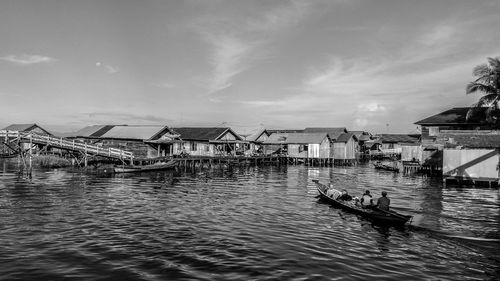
[0,161,500,280]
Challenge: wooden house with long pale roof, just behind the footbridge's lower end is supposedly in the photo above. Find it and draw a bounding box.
[68,125,175,159]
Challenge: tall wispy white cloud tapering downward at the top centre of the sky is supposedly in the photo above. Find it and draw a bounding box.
[194,1,309,94]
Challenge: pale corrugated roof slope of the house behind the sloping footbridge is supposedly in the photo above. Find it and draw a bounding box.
[100,126,166,140]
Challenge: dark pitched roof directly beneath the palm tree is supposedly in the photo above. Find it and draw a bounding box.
[414,107,488,125]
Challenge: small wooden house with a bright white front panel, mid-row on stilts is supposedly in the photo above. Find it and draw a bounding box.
[285,133,331,159]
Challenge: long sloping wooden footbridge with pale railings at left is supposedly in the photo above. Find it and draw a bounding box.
[0,130,134,163]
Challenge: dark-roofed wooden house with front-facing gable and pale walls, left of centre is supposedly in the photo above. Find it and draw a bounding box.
[172,127,244,157]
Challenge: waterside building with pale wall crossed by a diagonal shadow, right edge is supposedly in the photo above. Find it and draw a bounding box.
[440,131,500,186]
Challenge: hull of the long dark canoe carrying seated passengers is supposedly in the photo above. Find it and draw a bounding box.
[313,180,412,225]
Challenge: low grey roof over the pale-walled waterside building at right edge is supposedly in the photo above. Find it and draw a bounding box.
[441,134,500,148]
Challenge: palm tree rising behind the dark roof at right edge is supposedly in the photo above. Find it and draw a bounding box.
[465,57,500,126]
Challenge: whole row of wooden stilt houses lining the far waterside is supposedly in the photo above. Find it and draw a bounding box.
[2,107,500,184]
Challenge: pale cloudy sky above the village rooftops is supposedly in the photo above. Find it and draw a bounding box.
[0,0,500,134]
